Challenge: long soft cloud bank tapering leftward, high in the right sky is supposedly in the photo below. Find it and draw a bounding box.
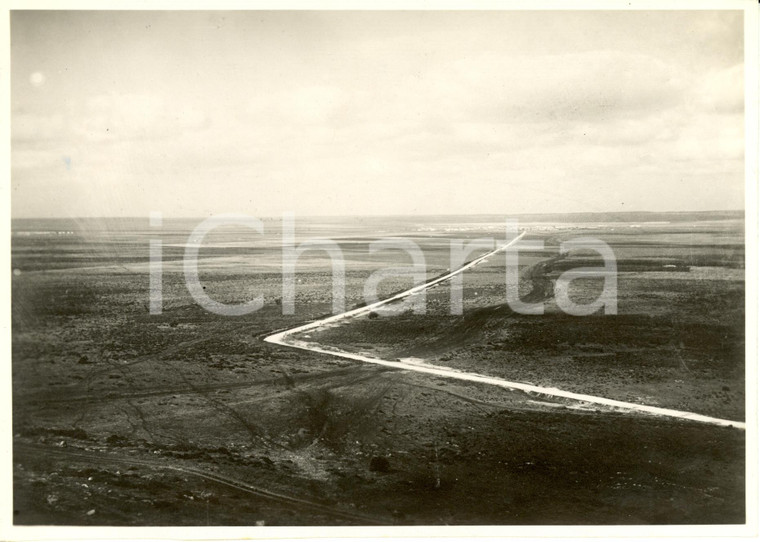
[246,50,695,138]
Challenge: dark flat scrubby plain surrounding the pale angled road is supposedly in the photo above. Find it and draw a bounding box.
[12,216,745,525]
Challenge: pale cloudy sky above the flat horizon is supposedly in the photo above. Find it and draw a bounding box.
[11,11,744,217]
